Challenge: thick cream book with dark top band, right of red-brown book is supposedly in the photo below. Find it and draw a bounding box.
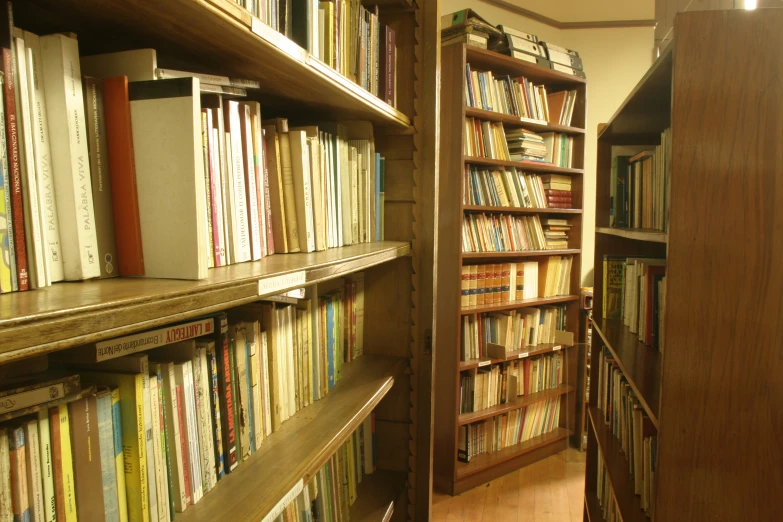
[128,78,209,279]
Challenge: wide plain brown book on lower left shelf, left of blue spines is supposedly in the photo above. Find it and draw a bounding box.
[68,394,106,521]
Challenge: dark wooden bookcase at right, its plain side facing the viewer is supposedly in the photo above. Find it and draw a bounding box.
[584,9,783,522]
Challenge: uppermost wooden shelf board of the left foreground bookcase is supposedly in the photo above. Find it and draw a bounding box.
[14,0,411,128]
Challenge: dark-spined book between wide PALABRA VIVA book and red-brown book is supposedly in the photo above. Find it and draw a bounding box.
[83,76,119,278]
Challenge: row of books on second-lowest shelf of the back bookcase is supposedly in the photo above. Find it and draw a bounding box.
[459,352,563,413]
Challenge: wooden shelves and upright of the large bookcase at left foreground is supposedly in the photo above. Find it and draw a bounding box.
[0,0,439,522]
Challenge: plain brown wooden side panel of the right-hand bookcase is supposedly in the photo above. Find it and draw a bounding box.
[656,9,783,522]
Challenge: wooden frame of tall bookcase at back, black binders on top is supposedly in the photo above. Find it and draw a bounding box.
[434,45,587,495]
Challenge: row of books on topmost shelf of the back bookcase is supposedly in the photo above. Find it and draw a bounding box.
[464,64,576,125]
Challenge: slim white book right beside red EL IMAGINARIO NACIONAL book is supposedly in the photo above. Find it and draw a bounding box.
[14,36,47,288]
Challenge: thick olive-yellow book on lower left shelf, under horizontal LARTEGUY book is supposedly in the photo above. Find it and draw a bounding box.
[81,371,150,522]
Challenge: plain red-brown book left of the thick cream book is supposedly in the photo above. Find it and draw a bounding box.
[103,76,144,276]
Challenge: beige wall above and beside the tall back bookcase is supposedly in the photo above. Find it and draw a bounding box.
[441,0,654,286]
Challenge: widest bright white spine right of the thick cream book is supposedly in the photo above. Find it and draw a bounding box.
[225,100,251,263]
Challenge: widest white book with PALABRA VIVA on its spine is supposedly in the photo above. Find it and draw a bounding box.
[40,34,100,280]
